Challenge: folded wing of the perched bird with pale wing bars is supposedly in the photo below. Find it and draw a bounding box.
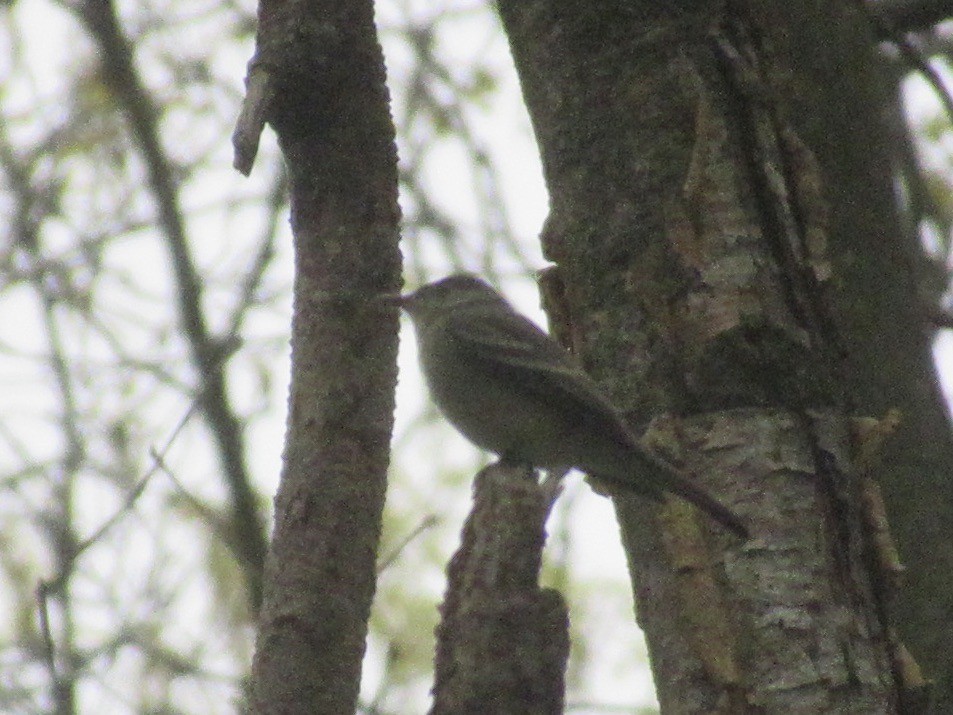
[447,313,632,441]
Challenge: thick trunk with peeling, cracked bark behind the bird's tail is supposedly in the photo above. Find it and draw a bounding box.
[498,0,936,713]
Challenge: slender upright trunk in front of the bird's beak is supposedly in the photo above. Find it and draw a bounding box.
[251,0,400,715]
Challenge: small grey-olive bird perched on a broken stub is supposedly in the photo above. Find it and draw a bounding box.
[398,273,749,539]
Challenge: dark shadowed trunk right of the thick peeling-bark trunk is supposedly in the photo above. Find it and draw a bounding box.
[758,2,953,713]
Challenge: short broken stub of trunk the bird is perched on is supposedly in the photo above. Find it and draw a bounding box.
[431,465,569,715]
